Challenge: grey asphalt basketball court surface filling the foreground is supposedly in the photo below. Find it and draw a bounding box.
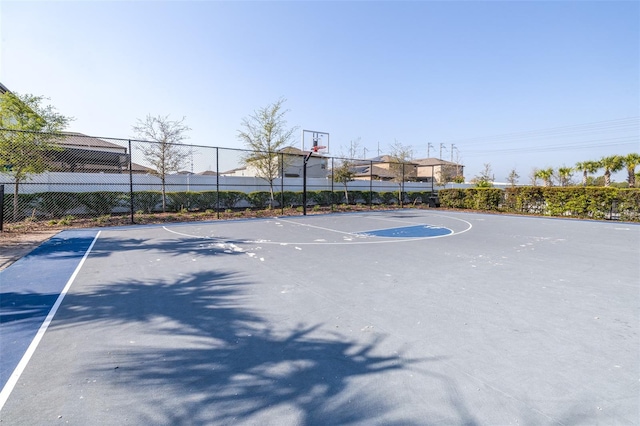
[0,210,640,425]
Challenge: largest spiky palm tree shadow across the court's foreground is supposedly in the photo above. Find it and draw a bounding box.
[52,271,473,425]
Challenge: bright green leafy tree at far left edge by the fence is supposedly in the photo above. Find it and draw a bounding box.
[0,92,73,220]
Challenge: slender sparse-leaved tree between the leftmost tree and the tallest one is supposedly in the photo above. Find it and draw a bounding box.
[133,115,191,212]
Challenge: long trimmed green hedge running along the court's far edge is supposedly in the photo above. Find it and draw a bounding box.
[4,186,640,222]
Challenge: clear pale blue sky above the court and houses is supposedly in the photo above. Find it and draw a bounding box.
[0,0,640,183]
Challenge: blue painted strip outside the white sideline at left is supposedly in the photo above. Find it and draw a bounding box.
[0,230,98,389]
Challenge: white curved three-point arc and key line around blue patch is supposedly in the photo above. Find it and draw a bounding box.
[162,215,473,245]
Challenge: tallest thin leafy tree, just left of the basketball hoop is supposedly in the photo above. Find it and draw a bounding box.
[238,98,297,207]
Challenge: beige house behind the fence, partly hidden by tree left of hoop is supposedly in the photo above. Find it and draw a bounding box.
[220,147,328,178]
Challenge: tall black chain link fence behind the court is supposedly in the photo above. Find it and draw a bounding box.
[0,129,436,223]
